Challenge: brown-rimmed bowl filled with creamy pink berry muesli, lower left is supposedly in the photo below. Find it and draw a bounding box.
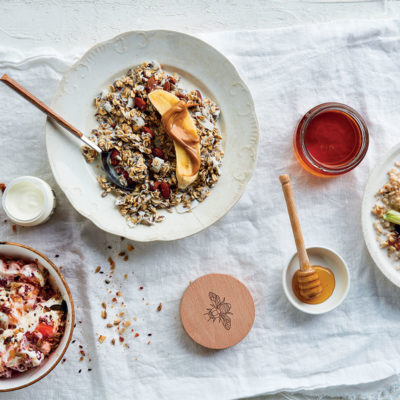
[0,242,74,392]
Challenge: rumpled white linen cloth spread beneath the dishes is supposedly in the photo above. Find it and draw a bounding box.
[0,20,400,400]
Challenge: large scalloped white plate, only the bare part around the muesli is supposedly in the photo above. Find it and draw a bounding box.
[46,31,258,241]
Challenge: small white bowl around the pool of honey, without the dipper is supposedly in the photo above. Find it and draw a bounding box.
[282,247,350,314]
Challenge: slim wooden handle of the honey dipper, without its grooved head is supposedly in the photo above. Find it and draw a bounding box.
[279,175,310,271]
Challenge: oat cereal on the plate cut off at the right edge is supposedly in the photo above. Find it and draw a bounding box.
[372,162,400,270]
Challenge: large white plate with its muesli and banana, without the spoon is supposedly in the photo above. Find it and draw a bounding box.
[46,30,259,242]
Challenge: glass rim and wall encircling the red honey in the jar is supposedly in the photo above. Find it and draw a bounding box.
[299,102,369,175]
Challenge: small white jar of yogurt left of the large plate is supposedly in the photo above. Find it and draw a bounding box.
[2,176,55,226]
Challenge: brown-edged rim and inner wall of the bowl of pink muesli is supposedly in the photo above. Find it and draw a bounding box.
[0,242,75,392]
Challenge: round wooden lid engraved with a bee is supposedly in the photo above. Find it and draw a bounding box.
[180,274,255,349]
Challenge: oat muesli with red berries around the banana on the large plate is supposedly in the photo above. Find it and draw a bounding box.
[82,62,224,227]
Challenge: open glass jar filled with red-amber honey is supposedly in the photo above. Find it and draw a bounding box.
[293,103,369,178]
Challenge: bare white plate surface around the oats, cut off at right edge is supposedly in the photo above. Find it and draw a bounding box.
[361,144,400,287]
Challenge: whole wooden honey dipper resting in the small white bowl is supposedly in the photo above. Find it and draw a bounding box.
[279,175,322,299]
